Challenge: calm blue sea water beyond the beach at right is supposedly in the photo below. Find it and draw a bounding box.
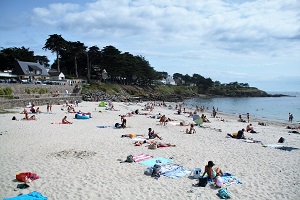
[184,92,300,122]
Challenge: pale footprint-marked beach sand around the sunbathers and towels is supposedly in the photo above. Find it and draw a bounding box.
[0,102,300,200]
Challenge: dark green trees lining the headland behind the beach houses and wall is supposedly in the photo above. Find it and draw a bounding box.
[0,34,256,92]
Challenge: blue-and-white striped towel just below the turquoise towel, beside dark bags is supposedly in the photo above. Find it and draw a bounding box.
[160,163,191,178]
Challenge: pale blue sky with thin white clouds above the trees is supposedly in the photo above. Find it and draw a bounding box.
[0,0,300,92]
